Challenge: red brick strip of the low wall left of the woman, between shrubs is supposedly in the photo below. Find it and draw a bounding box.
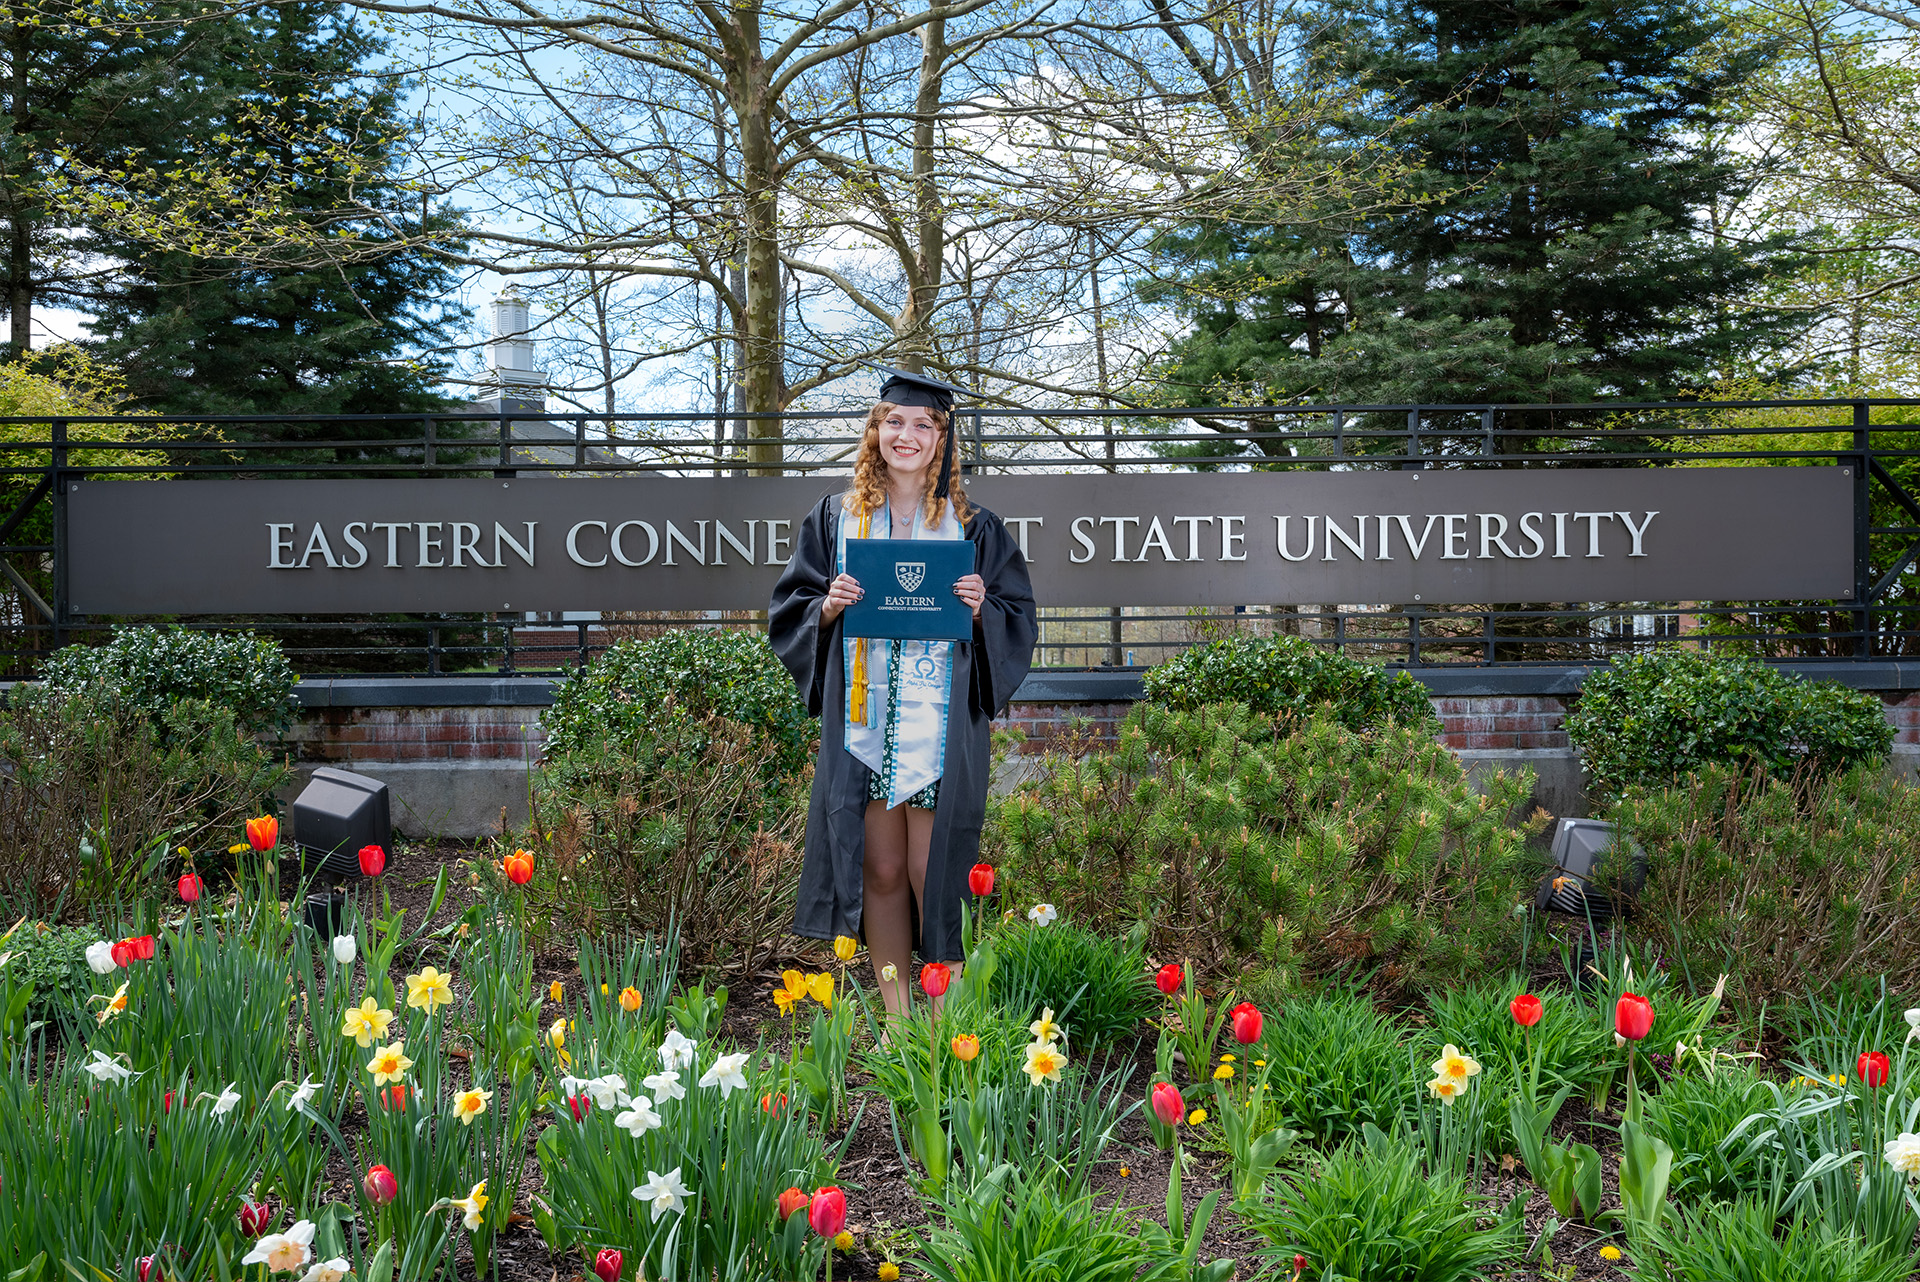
[284,708,547,768]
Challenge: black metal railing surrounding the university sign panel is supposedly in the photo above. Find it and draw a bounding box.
[0,399,1920,677]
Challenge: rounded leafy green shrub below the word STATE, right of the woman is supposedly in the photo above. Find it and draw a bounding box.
[1142,637,1440,729]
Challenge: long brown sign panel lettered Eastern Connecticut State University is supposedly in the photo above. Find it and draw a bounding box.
[69,466,1853,614]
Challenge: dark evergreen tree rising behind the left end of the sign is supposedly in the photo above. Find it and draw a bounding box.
[92,4,465,426]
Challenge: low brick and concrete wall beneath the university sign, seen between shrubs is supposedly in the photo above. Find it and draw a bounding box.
[280,681,1920,837]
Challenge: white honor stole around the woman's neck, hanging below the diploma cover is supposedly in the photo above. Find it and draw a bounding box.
[835,503,966,810]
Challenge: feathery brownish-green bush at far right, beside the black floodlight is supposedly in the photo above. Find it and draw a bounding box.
[1609,766,1920,1013]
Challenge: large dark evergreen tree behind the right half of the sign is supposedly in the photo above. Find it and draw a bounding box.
[1162,0,1805,416]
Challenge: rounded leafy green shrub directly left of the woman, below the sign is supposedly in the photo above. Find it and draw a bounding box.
[541,629,818,775]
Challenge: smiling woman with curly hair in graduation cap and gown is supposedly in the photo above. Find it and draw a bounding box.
[768,370,1035,1013]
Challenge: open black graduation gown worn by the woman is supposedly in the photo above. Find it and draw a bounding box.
[766,493,1037,962]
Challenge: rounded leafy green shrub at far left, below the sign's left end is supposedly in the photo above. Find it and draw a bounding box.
[27,628,300,733]
